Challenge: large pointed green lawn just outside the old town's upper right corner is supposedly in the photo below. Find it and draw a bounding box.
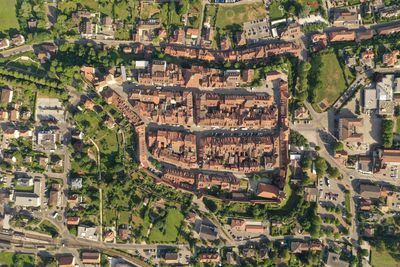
[310,52,347,111]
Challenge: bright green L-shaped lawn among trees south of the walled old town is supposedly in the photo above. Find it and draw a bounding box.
[149,208,183,245]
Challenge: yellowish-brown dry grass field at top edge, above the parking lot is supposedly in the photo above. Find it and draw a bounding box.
[206,2,267,29]
